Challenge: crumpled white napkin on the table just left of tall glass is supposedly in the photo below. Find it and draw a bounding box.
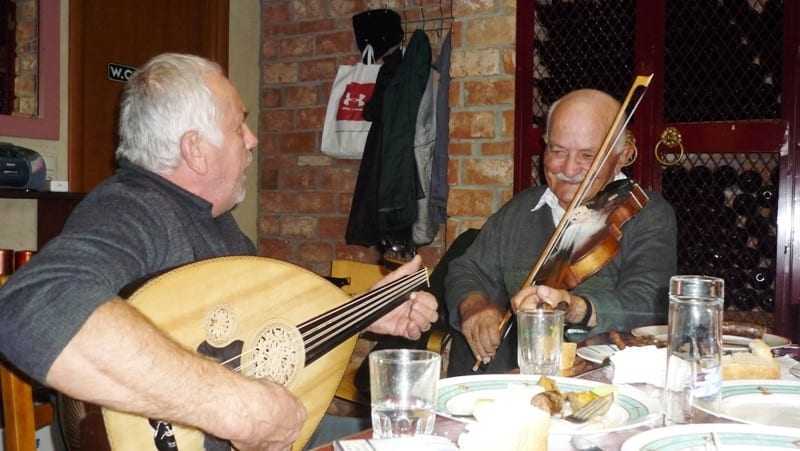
[610,346,667,387]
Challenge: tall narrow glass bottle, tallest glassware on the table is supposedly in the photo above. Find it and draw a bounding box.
[664,276,725,424]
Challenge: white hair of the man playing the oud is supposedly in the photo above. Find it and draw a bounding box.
[117,53,222,174]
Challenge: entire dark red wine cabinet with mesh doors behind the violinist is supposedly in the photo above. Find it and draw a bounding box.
[515,0,800,339]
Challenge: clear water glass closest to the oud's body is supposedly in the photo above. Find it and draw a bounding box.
[369,349,441,438]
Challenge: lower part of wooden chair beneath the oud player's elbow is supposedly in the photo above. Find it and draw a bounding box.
[0,363,53,451]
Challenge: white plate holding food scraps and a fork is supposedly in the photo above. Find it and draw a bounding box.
[436,374,661,435]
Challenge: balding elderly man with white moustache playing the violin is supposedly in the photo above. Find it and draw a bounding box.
[445,89,677,376]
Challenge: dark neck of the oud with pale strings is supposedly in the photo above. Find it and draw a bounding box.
[297,268,428,365]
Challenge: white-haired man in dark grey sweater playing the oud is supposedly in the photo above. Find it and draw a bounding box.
[0,54,437,450]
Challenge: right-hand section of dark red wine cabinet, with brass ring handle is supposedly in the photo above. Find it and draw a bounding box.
[636,0,800,340]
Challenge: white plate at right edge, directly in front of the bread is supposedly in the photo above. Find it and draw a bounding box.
[698,380,800,428]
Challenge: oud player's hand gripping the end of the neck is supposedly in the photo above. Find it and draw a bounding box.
[367,255,439,340]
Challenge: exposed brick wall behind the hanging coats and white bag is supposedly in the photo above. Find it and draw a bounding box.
[259,0,516,274]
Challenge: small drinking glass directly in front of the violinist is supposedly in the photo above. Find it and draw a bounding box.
[517,309,564,376]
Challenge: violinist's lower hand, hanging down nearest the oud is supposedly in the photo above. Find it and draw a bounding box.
[459,293,503,363]
